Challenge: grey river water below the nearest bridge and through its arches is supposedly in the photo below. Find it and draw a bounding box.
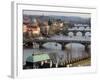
[23,42,88,65]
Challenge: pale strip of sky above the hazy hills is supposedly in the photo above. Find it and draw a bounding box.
[23,10,91,18]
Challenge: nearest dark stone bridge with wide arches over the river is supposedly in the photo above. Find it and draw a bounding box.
[26,39,91,50]
